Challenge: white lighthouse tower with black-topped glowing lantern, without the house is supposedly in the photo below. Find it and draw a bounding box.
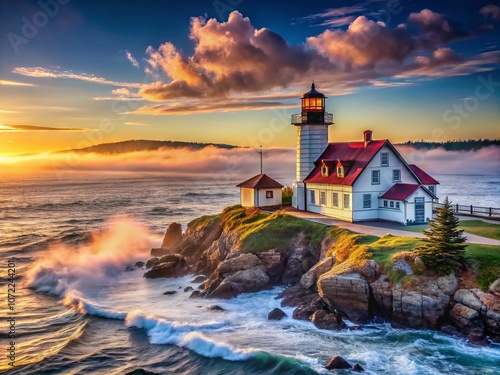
[292,82,333,210]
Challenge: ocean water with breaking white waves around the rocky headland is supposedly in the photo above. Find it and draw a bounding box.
[0,174,500,375]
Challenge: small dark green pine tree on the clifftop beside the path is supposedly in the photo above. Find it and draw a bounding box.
[416,197,467,275]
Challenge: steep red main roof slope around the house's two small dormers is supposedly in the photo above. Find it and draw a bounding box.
[304,139,387,186]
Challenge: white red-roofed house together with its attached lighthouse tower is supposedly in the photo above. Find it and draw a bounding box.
[292,84,439,224]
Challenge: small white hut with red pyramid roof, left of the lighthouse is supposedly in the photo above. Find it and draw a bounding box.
[236,173,283,207]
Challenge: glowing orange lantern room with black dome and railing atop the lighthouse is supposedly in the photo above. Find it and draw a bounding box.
[292,82,333,125]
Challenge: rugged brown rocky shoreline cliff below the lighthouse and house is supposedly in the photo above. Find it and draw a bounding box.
[144,206,500,345]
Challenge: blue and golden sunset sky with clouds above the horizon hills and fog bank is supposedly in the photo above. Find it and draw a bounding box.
[0,0,500,157]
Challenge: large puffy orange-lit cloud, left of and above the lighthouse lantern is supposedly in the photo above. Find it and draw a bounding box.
[140,11,331,100]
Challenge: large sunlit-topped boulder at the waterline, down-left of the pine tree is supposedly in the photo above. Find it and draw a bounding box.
[317,272,370,323]
